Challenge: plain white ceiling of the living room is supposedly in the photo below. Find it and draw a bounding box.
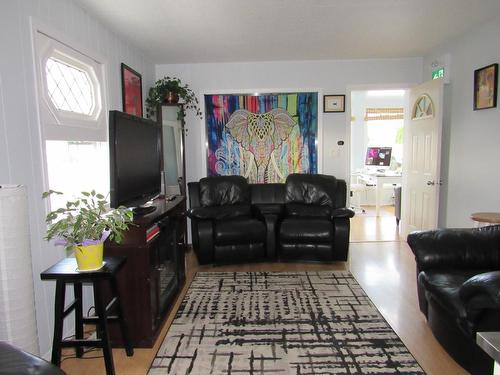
[76,0,500,64]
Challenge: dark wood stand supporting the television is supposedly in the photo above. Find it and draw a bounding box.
[104,196,186,347]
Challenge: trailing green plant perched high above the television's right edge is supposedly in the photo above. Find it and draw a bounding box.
[146,77,201,120]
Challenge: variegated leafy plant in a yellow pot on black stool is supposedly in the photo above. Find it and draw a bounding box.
[42,190,133,271]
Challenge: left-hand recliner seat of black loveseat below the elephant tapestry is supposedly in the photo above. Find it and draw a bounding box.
[188,176,266,264]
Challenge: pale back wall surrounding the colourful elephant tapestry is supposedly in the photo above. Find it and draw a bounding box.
[156,58,422,187]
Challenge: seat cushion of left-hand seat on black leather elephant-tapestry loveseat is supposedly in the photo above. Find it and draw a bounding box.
[214,217,266,245]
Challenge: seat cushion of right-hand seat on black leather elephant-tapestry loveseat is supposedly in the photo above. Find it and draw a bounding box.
[279,217,334,244]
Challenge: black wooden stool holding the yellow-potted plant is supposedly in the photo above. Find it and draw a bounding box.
[40,257,134,375]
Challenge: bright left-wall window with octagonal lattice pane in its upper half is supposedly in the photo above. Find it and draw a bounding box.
[35,32,109,209]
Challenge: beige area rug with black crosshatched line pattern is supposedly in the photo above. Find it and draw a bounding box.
[149,271,424,375]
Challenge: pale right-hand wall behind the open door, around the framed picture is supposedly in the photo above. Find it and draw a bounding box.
[423,18,500,227]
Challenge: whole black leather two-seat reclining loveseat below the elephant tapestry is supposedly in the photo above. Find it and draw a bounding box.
[188,174,354,264]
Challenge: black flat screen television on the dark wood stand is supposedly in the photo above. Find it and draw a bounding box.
[109,111,162,215]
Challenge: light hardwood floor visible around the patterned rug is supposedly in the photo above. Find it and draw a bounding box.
[62,214,467,375]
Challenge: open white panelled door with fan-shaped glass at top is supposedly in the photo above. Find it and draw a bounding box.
[401,78,443,238]
